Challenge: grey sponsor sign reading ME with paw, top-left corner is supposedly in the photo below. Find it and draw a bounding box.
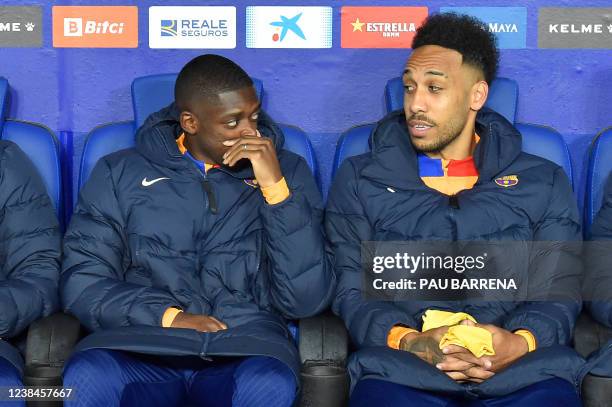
[0,6,42,47]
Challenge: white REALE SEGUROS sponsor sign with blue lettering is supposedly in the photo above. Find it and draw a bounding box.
[149,6,236,49]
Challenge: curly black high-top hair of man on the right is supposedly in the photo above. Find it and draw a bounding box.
[412,13,499,85]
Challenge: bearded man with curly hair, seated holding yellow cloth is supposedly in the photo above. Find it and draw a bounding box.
[326,14,582,406]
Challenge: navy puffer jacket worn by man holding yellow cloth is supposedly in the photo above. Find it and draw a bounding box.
[326,109,583,397]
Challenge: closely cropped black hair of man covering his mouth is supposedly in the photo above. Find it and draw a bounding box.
[174,54,253,111]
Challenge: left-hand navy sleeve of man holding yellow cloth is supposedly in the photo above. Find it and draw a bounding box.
[325,159,417,348]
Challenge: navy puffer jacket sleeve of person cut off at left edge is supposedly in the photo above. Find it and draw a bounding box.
[0,143,61,337]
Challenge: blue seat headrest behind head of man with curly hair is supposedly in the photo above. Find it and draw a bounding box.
[385,78,518,123]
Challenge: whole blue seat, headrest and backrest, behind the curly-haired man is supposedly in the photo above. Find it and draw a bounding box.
[332,78,573,186]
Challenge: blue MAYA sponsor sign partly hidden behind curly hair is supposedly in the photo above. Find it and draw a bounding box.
[440,7,527,49]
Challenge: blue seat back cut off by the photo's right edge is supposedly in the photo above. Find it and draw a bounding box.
[584,127,612,236]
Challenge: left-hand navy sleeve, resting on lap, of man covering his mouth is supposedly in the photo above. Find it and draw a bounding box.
[60,159,179,331]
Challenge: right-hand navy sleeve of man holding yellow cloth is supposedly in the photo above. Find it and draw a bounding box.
[503,168,582,348]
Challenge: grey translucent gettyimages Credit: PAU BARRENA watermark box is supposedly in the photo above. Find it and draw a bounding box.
[361,241,582,301]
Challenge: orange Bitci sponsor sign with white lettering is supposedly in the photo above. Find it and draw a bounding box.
[52,6,138,48]
